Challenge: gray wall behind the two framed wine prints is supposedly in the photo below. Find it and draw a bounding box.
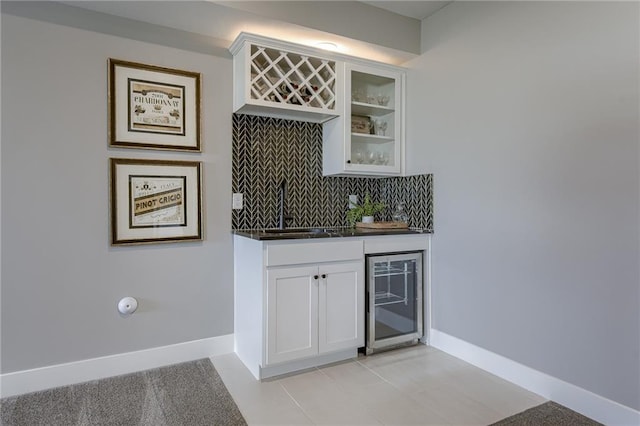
[2,14,233,373]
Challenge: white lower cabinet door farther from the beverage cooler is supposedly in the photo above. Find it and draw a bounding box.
[266,266,319,365]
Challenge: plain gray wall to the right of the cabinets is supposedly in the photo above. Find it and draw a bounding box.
[406,2,640,409]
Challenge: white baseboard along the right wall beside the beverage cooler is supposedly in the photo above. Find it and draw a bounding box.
[429,329,640,426]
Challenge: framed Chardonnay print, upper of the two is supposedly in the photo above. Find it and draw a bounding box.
[108,59,200,152]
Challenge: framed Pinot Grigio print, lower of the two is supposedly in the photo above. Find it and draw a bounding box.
[109,158,202,245]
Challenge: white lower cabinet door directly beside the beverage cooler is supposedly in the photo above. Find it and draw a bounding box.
[318,262,365,353]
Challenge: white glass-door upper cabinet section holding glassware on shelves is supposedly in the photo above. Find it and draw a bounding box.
[322,62,406,177]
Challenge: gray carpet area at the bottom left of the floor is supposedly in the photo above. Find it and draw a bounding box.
[0,358,247,426]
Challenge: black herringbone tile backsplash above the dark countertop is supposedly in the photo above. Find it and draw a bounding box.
[231,114,433,230]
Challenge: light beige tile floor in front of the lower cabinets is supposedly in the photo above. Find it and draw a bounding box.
[211,345,546,425]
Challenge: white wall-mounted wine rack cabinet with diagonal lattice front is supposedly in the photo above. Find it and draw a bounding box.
[229,33,344,123]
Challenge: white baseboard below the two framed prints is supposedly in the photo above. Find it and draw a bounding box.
[0,334,233,398]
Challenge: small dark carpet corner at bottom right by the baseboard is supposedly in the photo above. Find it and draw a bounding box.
[491,401,602,426]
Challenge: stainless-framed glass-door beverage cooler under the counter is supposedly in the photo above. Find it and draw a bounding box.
[365,251,423,355]
